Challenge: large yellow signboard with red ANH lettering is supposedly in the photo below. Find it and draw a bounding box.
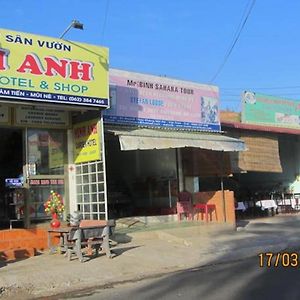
[0,29,109,107]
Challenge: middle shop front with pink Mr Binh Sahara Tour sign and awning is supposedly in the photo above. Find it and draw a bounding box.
[104,69,244,223]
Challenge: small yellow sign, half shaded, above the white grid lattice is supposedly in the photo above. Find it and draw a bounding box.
[74,119,101,163]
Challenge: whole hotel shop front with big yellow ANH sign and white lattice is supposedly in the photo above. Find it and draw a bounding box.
[0,29,109,228]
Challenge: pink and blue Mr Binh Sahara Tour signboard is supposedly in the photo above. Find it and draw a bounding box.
[103,69,220,131]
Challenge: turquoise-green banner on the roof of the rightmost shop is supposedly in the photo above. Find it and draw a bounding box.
[242,92,300,129]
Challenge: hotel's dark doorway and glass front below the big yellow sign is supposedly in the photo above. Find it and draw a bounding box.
[0,109,69,228]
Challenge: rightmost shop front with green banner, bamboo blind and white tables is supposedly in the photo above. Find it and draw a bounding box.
[221,92,300,216]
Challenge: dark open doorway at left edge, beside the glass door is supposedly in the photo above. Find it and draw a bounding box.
[0,128,24,228]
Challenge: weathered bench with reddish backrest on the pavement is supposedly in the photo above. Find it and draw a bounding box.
[66,220,115,262]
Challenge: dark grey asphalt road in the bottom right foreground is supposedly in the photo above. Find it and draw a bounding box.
[56,255,300,300]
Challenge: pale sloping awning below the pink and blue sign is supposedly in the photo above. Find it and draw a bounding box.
[107,128,246,151]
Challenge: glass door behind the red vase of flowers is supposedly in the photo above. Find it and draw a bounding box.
[26,129,68,222]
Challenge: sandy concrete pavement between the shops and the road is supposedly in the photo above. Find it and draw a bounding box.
[0,214,300,299]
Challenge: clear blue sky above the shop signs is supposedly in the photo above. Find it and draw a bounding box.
[0,0,300,111]
